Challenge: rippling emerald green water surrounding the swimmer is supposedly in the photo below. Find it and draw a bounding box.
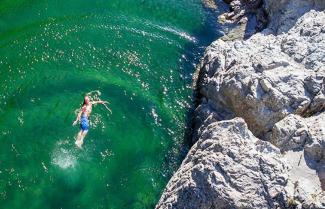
[0,0,218,209]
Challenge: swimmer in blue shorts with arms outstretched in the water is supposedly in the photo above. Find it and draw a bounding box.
[73,96,112,147]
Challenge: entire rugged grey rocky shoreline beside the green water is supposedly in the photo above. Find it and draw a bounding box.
[156,0,325,209]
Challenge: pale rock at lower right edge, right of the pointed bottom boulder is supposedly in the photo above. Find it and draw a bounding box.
[270,112,325,208]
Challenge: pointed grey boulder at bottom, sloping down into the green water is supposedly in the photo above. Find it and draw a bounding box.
[156,118,288,209]
